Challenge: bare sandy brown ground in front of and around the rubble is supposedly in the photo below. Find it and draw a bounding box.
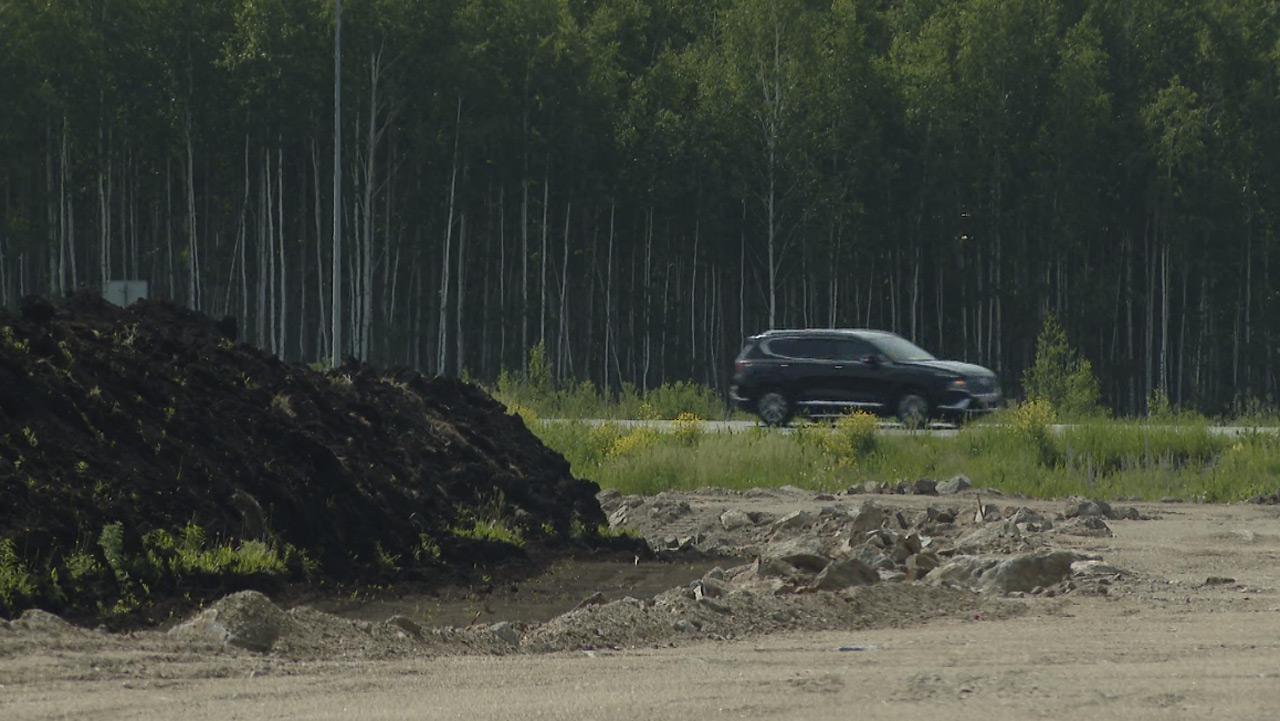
[0,490,1280,721]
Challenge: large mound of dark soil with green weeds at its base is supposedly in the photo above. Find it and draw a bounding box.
[0,295,604,615]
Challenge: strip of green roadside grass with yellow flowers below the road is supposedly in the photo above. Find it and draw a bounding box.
[531,409,1280,502]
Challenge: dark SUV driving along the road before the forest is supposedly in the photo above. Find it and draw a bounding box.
[730,330,1001,426]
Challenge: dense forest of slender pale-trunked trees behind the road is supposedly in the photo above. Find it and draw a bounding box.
[0,0,1280,415]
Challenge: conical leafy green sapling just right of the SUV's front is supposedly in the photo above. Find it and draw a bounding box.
[1023,312,1102,420]
